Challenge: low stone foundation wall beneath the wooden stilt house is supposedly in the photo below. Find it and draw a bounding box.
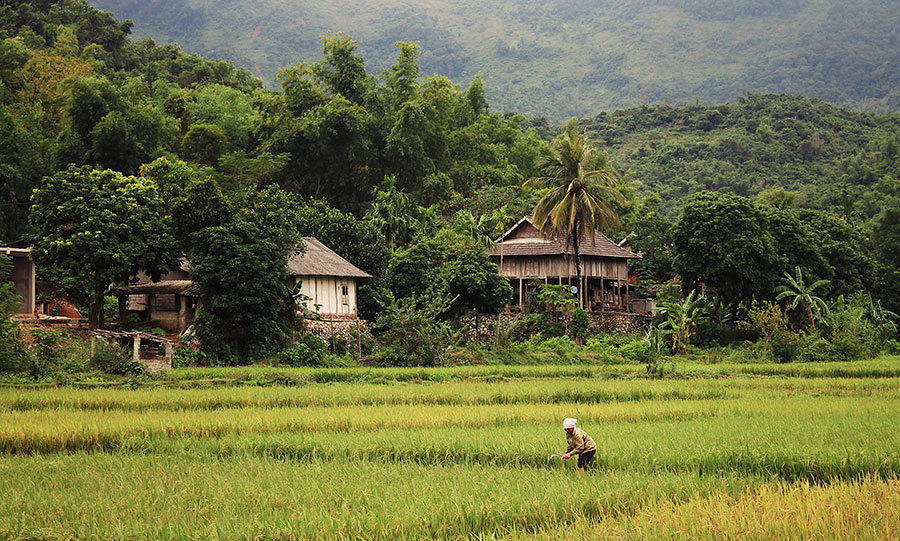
[460,312,651,342]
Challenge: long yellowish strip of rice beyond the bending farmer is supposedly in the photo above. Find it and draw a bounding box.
[0,378,728,412]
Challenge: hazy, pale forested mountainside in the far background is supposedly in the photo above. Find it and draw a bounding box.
[92,0,900,121]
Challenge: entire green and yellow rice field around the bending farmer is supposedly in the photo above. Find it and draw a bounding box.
[0,358,900,539]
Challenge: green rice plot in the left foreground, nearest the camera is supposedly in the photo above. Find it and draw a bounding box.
[0,454,761,539]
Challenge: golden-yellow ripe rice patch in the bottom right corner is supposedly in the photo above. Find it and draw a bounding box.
[528,479,900,540]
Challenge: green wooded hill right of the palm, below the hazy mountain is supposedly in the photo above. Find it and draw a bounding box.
[582,94,900,221]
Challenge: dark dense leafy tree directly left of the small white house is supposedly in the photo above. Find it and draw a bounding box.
[181,186,303,364]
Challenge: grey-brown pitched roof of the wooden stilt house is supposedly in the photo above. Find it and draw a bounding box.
[488,216,640,259]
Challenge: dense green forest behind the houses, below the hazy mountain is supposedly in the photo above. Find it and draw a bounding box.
[0,0,900,363]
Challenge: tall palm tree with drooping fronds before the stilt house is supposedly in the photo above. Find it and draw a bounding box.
[525,122,625,306]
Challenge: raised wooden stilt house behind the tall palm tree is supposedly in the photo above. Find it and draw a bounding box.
[489,216,639,312]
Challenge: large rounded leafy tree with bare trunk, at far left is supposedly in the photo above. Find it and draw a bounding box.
[30,166,175,327]
